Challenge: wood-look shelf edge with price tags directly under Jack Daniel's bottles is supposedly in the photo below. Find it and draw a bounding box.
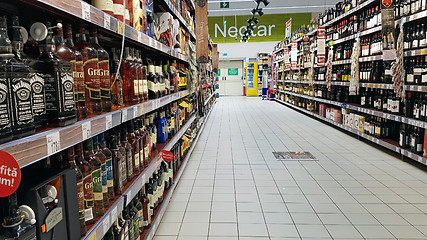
[0,91,189,168]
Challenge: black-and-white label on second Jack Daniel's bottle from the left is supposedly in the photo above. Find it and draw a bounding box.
[10,76,34,125]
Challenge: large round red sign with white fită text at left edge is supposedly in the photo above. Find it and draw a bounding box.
[0,151,21,197]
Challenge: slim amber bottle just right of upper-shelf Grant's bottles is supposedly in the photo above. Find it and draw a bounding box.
[110,48,124,111]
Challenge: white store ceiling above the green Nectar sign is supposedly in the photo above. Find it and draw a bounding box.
[208,0,337,16]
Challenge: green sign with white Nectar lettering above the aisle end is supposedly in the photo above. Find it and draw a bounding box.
[209,13,311,43]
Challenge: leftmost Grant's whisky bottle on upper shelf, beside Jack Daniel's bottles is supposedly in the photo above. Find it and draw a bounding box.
[65,24,87,120]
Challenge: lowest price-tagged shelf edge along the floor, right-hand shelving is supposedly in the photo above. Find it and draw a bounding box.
[275,99,427,165]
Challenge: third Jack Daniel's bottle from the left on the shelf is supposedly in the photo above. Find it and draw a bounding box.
[8,16,47,130]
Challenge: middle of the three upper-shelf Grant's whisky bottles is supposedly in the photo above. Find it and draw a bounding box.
[76,24,102,114]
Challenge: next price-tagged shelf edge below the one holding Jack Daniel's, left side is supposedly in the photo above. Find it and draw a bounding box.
[82,113,196,240]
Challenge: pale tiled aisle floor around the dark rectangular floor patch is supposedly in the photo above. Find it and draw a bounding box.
[155,97,427,240]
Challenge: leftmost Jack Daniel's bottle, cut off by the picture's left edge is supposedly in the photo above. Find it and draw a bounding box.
[0,17,13,143]
